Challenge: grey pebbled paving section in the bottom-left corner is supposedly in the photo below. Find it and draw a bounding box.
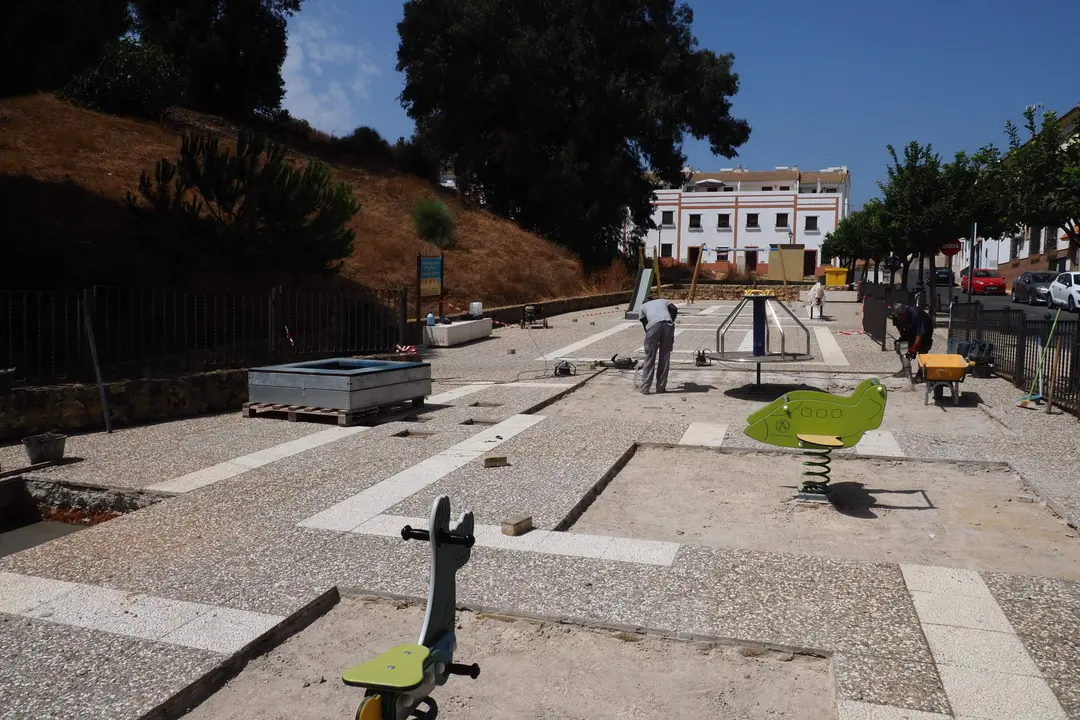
[0,615,225,720]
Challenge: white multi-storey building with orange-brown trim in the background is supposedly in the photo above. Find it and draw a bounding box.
[645,165,851,275]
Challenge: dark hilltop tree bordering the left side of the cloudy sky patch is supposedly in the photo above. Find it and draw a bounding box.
[132,0,300,117]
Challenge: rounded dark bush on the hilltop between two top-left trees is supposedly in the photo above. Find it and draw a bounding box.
[63,38,183,120]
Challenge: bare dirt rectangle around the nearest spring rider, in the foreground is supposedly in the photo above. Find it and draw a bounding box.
[186,596,835,720]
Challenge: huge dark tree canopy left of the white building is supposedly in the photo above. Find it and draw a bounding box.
[397,0,750,264]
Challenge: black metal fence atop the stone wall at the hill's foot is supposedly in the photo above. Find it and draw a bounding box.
[0,287,407,385]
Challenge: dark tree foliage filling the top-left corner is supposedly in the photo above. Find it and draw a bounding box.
[0,0,131,97]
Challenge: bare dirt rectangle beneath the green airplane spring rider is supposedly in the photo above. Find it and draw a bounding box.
[573,448,1080,580]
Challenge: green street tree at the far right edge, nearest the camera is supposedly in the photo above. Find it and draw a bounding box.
[1001,107,1080,260]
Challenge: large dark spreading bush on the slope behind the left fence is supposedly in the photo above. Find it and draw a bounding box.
[126,132,360,272]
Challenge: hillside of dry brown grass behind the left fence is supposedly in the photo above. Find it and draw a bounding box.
[0,95,626,307]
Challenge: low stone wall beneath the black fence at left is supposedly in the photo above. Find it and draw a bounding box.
[0,370,247,440]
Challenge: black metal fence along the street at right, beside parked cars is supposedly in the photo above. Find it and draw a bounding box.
[949,302,1080,413]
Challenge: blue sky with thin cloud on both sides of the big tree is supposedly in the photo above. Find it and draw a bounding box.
[283,0,1080,205]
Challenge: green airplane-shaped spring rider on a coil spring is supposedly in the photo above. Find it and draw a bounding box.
[743,378,889,495]
